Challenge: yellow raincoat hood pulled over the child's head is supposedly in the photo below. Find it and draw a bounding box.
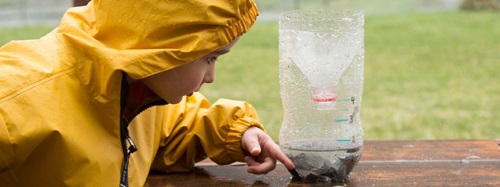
[60,0,258,99]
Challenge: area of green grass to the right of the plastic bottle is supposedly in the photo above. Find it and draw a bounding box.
[362,12,500,139]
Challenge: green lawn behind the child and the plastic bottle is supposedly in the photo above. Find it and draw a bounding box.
[0,12,500,140]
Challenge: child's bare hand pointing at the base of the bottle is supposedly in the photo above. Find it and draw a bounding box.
[241,127,295,174]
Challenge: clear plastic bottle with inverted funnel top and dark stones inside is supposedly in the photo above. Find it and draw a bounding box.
[279,10,364,182]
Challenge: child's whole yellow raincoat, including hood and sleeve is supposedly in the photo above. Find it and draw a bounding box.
[0,0,263,186]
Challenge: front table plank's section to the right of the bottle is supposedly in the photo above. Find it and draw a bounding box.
[347,160,500,186]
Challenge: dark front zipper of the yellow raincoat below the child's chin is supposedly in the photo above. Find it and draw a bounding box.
[120,73,167,187]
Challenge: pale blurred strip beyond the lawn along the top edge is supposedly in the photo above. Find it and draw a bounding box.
[0,0,462,27]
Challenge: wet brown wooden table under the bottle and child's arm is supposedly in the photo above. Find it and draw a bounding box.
[146,140,500,187]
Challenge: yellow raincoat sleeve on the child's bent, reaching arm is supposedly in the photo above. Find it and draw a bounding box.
[152,93,264,171]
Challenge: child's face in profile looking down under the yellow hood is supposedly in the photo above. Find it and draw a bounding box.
[142,37,239,104]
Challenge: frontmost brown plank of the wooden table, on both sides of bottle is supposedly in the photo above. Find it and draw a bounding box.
[147,161,500,186]
